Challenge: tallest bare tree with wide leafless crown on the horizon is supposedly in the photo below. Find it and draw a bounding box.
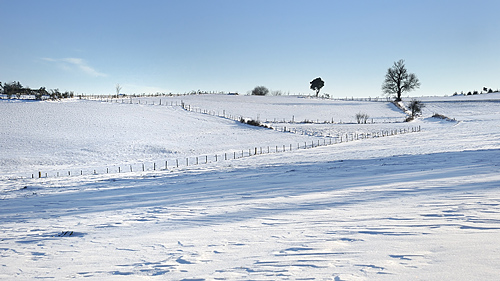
[382,60,420,101]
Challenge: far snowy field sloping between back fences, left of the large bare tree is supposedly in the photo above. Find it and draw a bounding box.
[130,95,405,123]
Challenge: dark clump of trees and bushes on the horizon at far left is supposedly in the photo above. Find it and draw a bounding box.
[0,81,74,100]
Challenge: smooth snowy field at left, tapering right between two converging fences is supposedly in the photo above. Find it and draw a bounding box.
[0,100,324,175]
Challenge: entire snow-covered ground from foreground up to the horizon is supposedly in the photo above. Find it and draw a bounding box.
[0,94,500,280]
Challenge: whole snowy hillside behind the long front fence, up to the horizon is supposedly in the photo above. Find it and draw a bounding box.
[0,95,408,177]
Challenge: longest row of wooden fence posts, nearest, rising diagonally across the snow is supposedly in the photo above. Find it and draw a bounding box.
[26,126,421,178]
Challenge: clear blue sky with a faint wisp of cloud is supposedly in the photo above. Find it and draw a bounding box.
[0,0,500,97]
